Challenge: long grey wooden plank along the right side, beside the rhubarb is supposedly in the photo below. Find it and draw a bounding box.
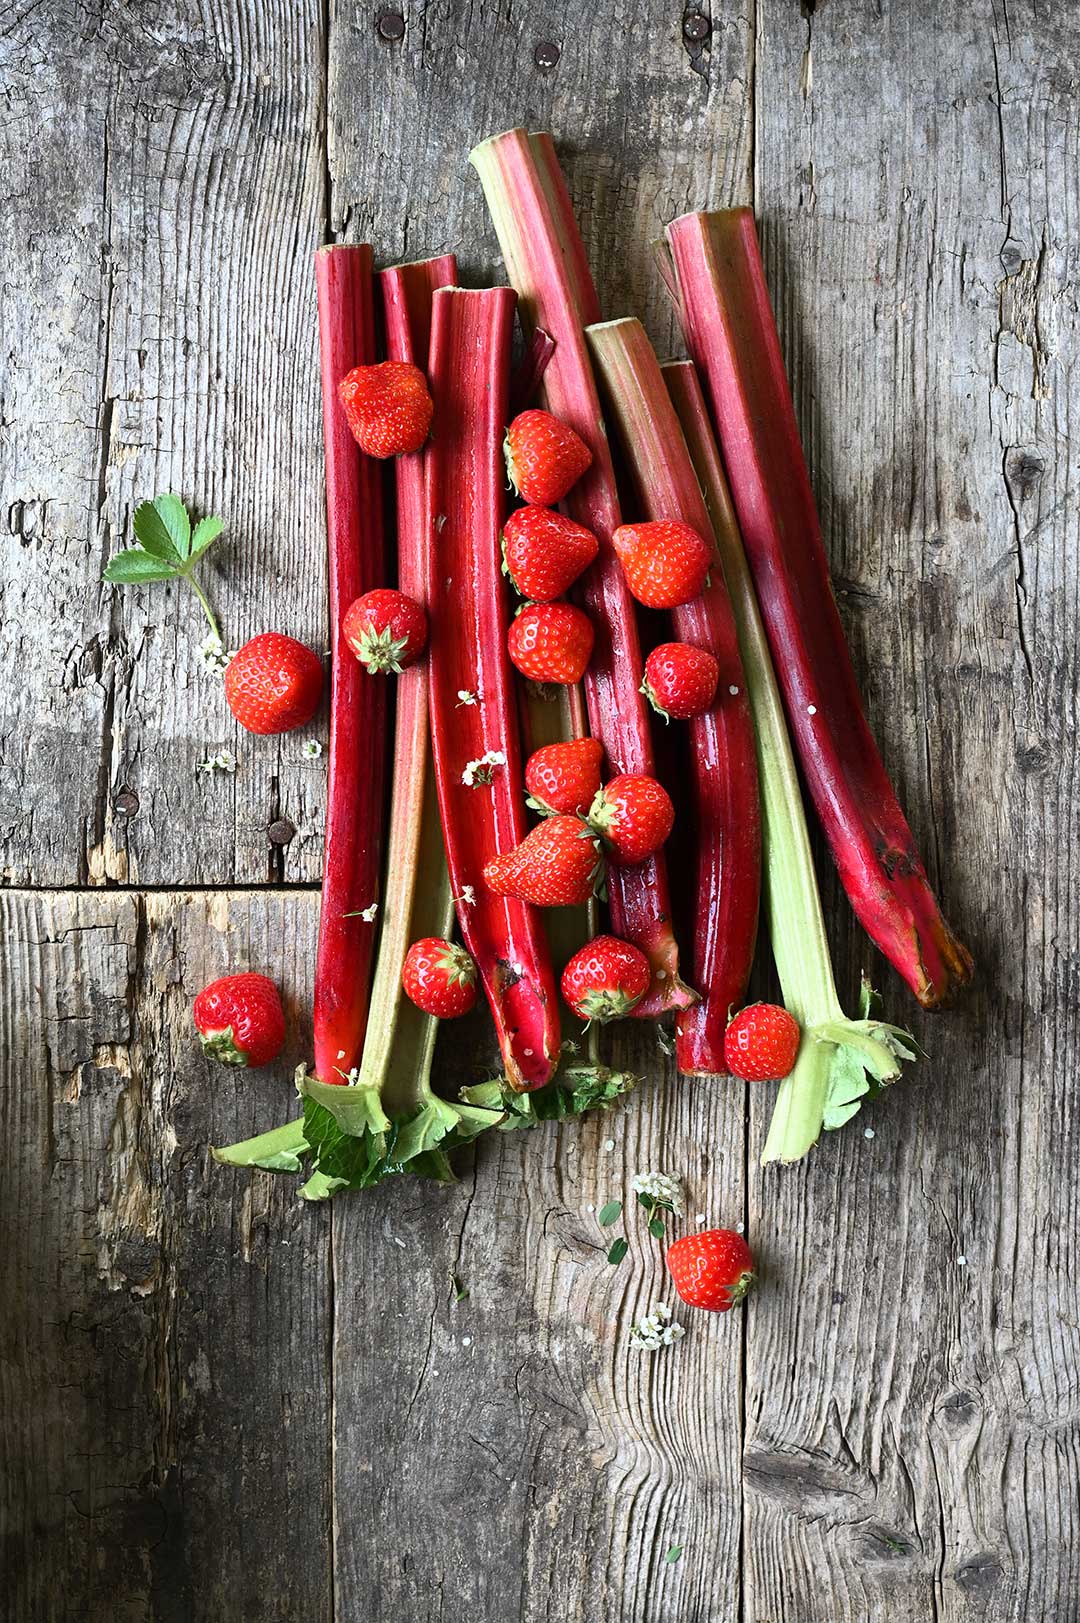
[745,0,1080,1623]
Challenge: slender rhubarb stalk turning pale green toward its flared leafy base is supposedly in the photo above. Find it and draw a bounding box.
[663,360,916,1165]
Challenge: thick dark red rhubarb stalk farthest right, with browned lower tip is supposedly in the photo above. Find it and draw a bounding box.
[667,209,973,1008]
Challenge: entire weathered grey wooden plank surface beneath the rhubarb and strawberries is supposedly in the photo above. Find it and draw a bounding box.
[0,0,1080,1623]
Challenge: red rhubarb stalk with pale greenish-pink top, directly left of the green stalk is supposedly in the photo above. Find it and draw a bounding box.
[588,320,762,1074]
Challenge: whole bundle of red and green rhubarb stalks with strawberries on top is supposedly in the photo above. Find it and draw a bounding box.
[200,130,971,1198]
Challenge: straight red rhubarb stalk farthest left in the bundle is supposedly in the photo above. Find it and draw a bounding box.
[313,245,387,1083]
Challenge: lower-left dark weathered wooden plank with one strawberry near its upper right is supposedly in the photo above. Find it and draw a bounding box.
[0,891,331,1623]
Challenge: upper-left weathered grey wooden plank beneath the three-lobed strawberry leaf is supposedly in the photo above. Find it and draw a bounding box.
[0,0,326,885]
